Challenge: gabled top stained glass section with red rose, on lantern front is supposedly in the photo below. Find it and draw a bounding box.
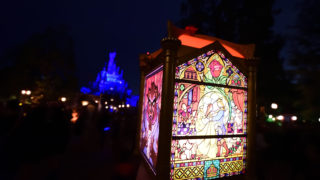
[175,50,247,87]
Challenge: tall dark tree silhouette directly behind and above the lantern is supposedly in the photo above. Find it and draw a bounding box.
[179,0,294,110]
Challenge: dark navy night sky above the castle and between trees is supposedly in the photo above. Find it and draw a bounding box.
[0,0,294,94]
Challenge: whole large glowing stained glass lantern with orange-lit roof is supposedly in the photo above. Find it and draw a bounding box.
[138,24,256,179]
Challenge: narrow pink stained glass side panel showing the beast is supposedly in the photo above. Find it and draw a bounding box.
[140,67,163,168]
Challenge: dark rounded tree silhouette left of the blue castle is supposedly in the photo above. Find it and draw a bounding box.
[0,27,77,100]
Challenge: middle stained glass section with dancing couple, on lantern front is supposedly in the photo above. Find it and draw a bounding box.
[172,83,247,136]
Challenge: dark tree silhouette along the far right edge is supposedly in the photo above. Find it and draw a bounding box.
[290,0,320,121]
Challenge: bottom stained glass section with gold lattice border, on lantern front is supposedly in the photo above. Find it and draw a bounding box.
[171,137,246,179]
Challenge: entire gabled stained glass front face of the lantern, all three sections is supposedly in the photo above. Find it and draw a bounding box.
[171,51,247,179]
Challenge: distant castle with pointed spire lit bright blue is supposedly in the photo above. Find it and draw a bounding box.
[80,52,139,106]
